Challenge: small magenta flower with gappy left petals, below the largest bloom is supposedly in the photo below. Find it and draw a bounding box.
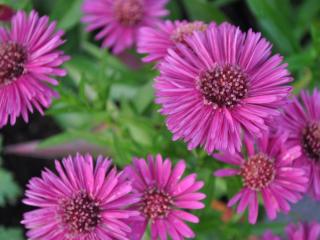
[213,134,308,224]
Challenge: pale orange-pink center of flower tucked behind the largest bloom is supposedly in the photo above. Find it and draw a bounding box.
[171,21,208,44]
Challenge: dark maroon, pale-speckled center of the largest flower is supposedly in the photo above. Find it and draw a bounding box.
[196,64,248,108]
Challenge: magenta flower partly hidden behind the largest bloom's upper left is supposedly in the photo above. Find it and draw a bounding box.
[138,20,208,62]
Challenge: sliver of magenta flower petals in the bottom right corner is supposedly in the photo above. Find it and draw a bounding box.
[286,222,320,240]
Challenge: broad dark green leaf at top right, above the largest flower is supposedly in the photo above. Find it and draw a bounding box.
[247,0,299,53]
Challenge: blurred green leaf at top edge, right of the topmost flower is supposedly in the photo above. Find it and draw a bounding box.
[183,0,226,23]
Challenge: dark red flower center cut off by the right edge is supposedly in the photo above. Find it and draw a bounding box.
[302,122,320,161]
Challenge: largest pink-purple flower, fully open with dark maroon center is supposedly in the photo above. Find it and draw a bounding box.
[155,23,291,153]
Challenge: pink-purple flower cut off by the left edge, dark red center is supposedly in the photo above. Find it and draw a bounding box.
[0,11,68,127]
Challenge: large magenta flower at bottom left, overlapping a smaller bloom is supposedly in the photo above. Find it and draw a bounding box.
[22,154,138,240]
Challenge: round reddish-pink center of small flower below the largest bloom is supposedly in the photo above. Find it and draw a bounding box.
[240,153,275,191]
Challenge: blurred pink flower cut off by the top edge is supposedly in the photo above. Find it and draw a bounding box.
[82,0,169,54]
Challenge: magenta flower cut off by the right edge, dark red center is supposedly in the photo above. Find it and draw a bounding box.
[279,89,320,199]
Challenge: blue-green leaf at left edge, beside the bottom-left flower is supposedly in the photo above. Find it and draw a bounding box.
[0,168,20,205]
